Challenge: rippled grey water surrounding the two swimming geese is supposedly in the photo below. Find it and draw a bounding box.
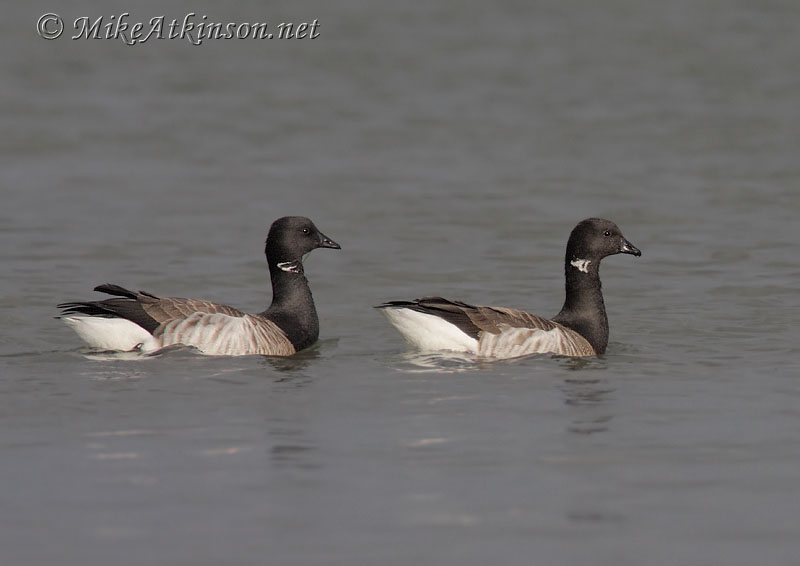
[0,0,800,566]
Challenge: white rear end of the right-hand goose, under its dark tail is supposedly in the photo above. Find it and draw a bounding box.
[381,308,478,354]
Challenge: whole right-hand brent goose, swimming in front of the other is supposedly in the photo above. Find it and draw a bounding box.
[376,218,642,359]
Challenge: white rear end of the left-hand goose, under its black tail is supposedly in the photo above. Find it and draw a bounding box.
[61,316,159,352]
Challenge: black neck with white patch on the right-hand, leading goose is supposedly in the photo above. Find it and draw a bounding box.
[553,254,608,354]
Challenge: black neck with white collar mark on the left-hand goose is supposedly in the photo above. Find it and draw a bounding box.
[262,256,319,351]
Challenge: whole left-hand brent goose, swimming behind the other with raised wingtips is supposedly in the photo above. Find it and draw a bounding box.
[58,216,341,356]
